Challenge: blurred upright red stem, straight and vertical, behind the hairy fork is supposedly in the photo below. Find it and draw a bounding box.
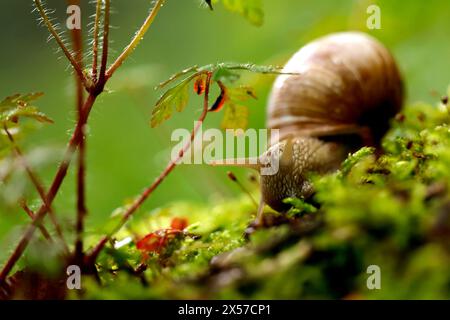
[68,0,88,261]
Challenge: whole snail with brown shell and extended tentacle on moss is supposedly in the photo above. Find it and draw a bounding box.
[213,32,403,221]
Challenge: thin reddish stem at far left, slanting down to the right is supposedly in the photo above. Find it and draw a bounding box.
[3,125,69,253]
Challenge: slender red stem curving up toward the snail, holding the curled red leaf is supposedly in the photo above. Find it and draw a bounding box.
[87,72,212,263]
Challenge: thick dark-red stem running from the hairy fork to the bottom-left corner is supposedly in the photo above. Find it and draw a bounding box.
[0,94,97,285]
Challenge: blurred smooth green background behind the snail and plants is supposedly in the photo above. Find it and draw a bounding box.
[0,0,450,260]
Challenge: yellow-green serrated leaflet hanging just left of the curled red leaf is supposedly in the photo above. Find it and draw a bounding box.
[150,79,190,128]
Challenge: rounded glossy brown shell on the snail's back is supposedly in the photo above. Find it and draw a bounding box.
[267,32,403,142]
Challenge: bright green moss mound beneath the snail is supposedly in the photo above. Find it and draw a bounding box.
[77,100,450,299]
